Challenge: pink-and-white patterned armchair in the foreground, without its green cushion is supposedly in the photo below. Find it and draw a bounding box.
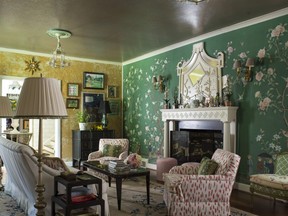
[163,149,240,216]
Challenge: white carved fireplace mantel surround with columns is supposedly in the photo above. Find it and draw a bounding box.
[161,107,238,157]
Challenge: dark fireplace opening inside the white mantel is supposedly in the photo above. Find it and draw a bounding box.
[170,121,223,165]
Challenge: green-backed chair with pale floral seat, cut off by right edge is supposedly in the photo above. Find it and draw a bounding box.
[250,152,288,204]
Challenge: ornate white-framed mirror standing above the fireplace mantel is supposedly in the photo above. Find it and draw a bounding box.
[177,42,224,105]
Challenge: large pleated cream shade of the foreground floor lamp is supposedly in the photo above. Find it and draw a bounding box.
[15,77,67,118]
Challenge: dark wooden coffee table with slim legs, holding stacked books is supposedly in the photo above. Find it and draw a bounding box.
[83,161,150,210]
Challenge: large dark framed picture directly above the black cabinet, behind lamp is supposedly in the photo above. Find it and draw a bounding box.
[82,92,105,122]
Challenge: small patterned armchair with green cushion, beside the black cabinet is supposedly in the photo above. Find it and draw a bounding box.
[88,139,129,162]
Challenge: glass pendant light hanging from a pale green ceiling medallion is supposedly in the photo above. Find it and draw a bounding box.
[47,29,72,68]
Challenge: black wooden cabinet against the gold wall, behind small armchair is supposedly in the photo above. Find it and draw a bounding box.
[72,130,114,168]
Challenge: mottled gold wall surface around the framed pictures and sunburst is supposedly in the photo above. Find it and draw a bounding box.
[0,51,123,161]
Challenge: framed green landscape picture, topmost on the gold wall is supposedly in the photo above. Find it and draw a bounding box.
[83,72,105,89]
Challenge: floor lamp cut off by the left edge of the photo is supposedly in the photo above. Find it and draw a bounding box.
[0,96,13,191]
